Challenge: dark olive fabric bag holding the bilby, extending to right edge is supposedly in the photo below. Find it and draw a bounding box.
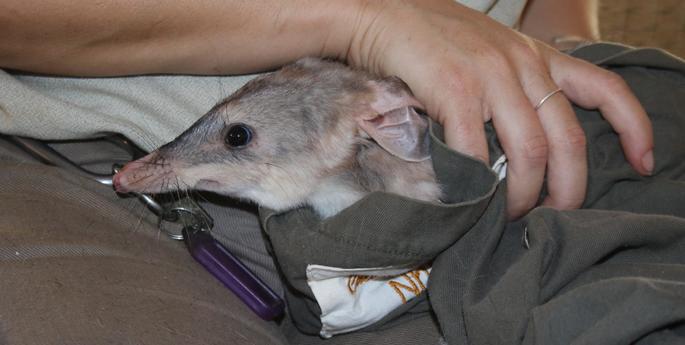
[260,44,685,344]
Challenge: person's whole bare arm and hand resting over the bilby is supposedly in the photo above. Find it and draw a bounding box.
[0,0,654,218]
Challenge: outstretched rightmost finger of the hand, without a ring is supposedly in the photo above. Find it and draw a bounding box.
[550,54,654,175]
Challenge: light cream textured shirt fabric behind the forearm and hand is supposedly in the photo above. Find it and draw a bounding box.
[0,0,525,150]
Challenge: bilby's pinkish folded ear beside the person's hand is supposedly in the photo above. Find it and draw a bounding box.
[358,107,430,162]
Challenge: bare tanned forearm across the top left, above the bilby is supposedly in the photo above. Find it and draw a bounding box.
[0,0,359,76]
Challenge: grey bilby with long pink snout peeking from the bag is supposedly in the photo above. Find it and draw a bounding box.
[114,58,441,217]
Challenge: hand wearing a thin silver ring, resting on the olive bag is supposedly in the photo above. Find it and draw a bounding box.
[346,0,654,219]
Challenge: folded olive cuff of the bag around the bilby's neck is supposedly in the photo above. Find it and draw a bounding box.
[260,119,503,334]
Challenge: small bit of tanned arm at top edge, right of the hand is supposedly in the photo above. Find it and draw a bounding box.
[520,0,599,43]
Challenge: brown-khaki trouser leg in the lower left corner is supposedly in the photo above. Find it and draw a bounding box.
[0,146,285,345]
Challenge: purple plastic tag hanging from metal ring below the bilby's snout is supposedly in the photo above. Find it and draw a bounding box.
[183,227,284,321]
